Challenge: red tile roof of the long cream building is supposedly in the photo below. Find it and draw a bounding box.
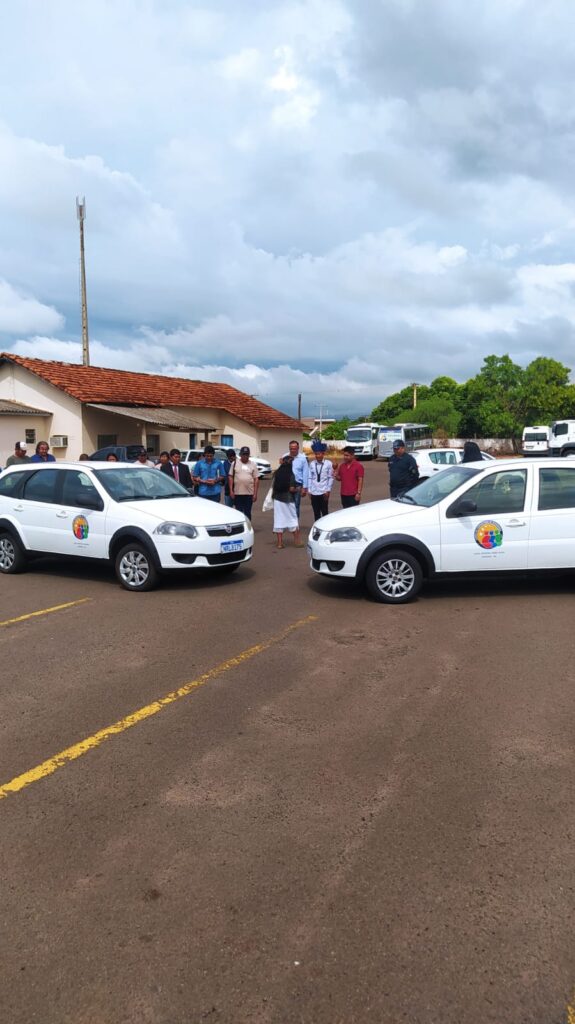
[0,352,302,433]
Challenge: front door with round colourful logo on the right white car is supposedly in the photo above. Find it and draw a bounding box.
[440,467,532,572]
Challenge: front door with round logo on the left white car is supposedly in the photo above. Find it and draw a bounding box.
[47,469,107,558]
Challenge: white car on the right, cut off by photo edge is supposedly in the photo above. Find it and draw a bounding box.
[308,458,575,604]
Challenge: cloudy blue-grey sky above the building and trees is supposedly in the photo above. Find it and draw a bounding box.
[0,0,575,416]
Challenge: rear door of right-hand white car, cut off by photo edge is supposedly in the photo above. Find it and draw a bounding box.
[529,465,575,569]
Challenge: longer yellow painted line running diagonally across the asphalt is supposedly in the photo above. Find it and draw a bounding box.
[0,615,317,800]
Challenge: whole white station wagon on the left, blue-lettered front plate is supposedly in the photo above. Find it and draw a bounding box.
[0,462,254,591]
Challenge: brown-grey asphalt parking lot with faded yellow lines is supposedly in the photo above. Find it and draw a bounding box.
[0,463,575,1024]
